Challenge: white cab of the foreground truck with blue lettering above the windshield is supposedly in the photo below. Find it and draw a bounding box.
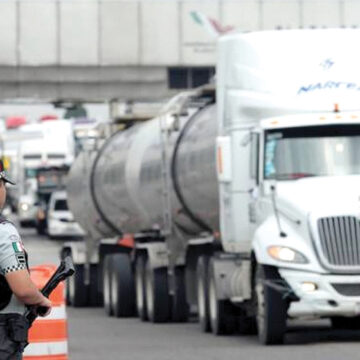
[215,30,360,344]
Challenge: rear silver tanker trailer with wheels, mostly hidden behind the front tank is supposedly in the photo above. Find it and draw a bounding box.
[61,149,136,312]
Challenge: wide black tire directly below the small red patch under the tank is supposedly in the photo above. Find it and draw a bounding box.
[111,254,136,317]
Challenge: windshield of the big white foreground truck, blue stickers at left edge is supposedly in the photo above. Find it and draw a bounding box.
[264,125,360,180]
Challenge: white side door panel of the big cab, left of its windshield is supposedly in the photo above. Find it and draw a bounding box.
[217,129,259,252]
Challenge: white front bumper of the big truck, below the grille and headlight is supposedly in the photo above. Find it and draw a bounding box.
[279,269,360,318]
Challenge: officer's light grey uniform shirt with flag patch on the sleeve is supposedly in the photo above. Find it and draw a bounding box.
[0,222,27,314]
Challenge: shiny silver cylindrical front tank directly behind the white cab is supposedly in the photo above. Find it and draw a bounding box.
[90,105,219,236]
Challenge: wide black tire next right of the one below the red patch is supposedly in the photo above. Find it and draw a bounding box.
[145,261,170,323]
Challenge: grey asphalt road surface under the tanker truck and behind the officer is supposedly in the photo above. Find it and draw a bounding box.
[16,222,360,360]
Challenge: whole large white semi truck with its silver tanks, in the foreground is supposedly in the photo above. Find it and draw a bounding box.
[63,29,360,344]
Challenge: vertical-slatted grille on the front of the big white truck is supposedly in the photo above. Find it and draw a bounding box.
[318,216,360,267]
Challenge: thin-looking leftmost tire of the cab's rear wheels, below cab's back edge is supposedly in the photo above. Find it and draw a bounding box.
[196,255,211,332]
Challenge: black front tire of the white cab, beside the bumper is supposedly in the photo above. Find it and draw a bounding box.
[254,265,288,345]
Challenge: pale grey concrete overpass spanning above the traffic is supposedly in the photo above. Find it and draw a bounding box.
[0,0,360,101]
